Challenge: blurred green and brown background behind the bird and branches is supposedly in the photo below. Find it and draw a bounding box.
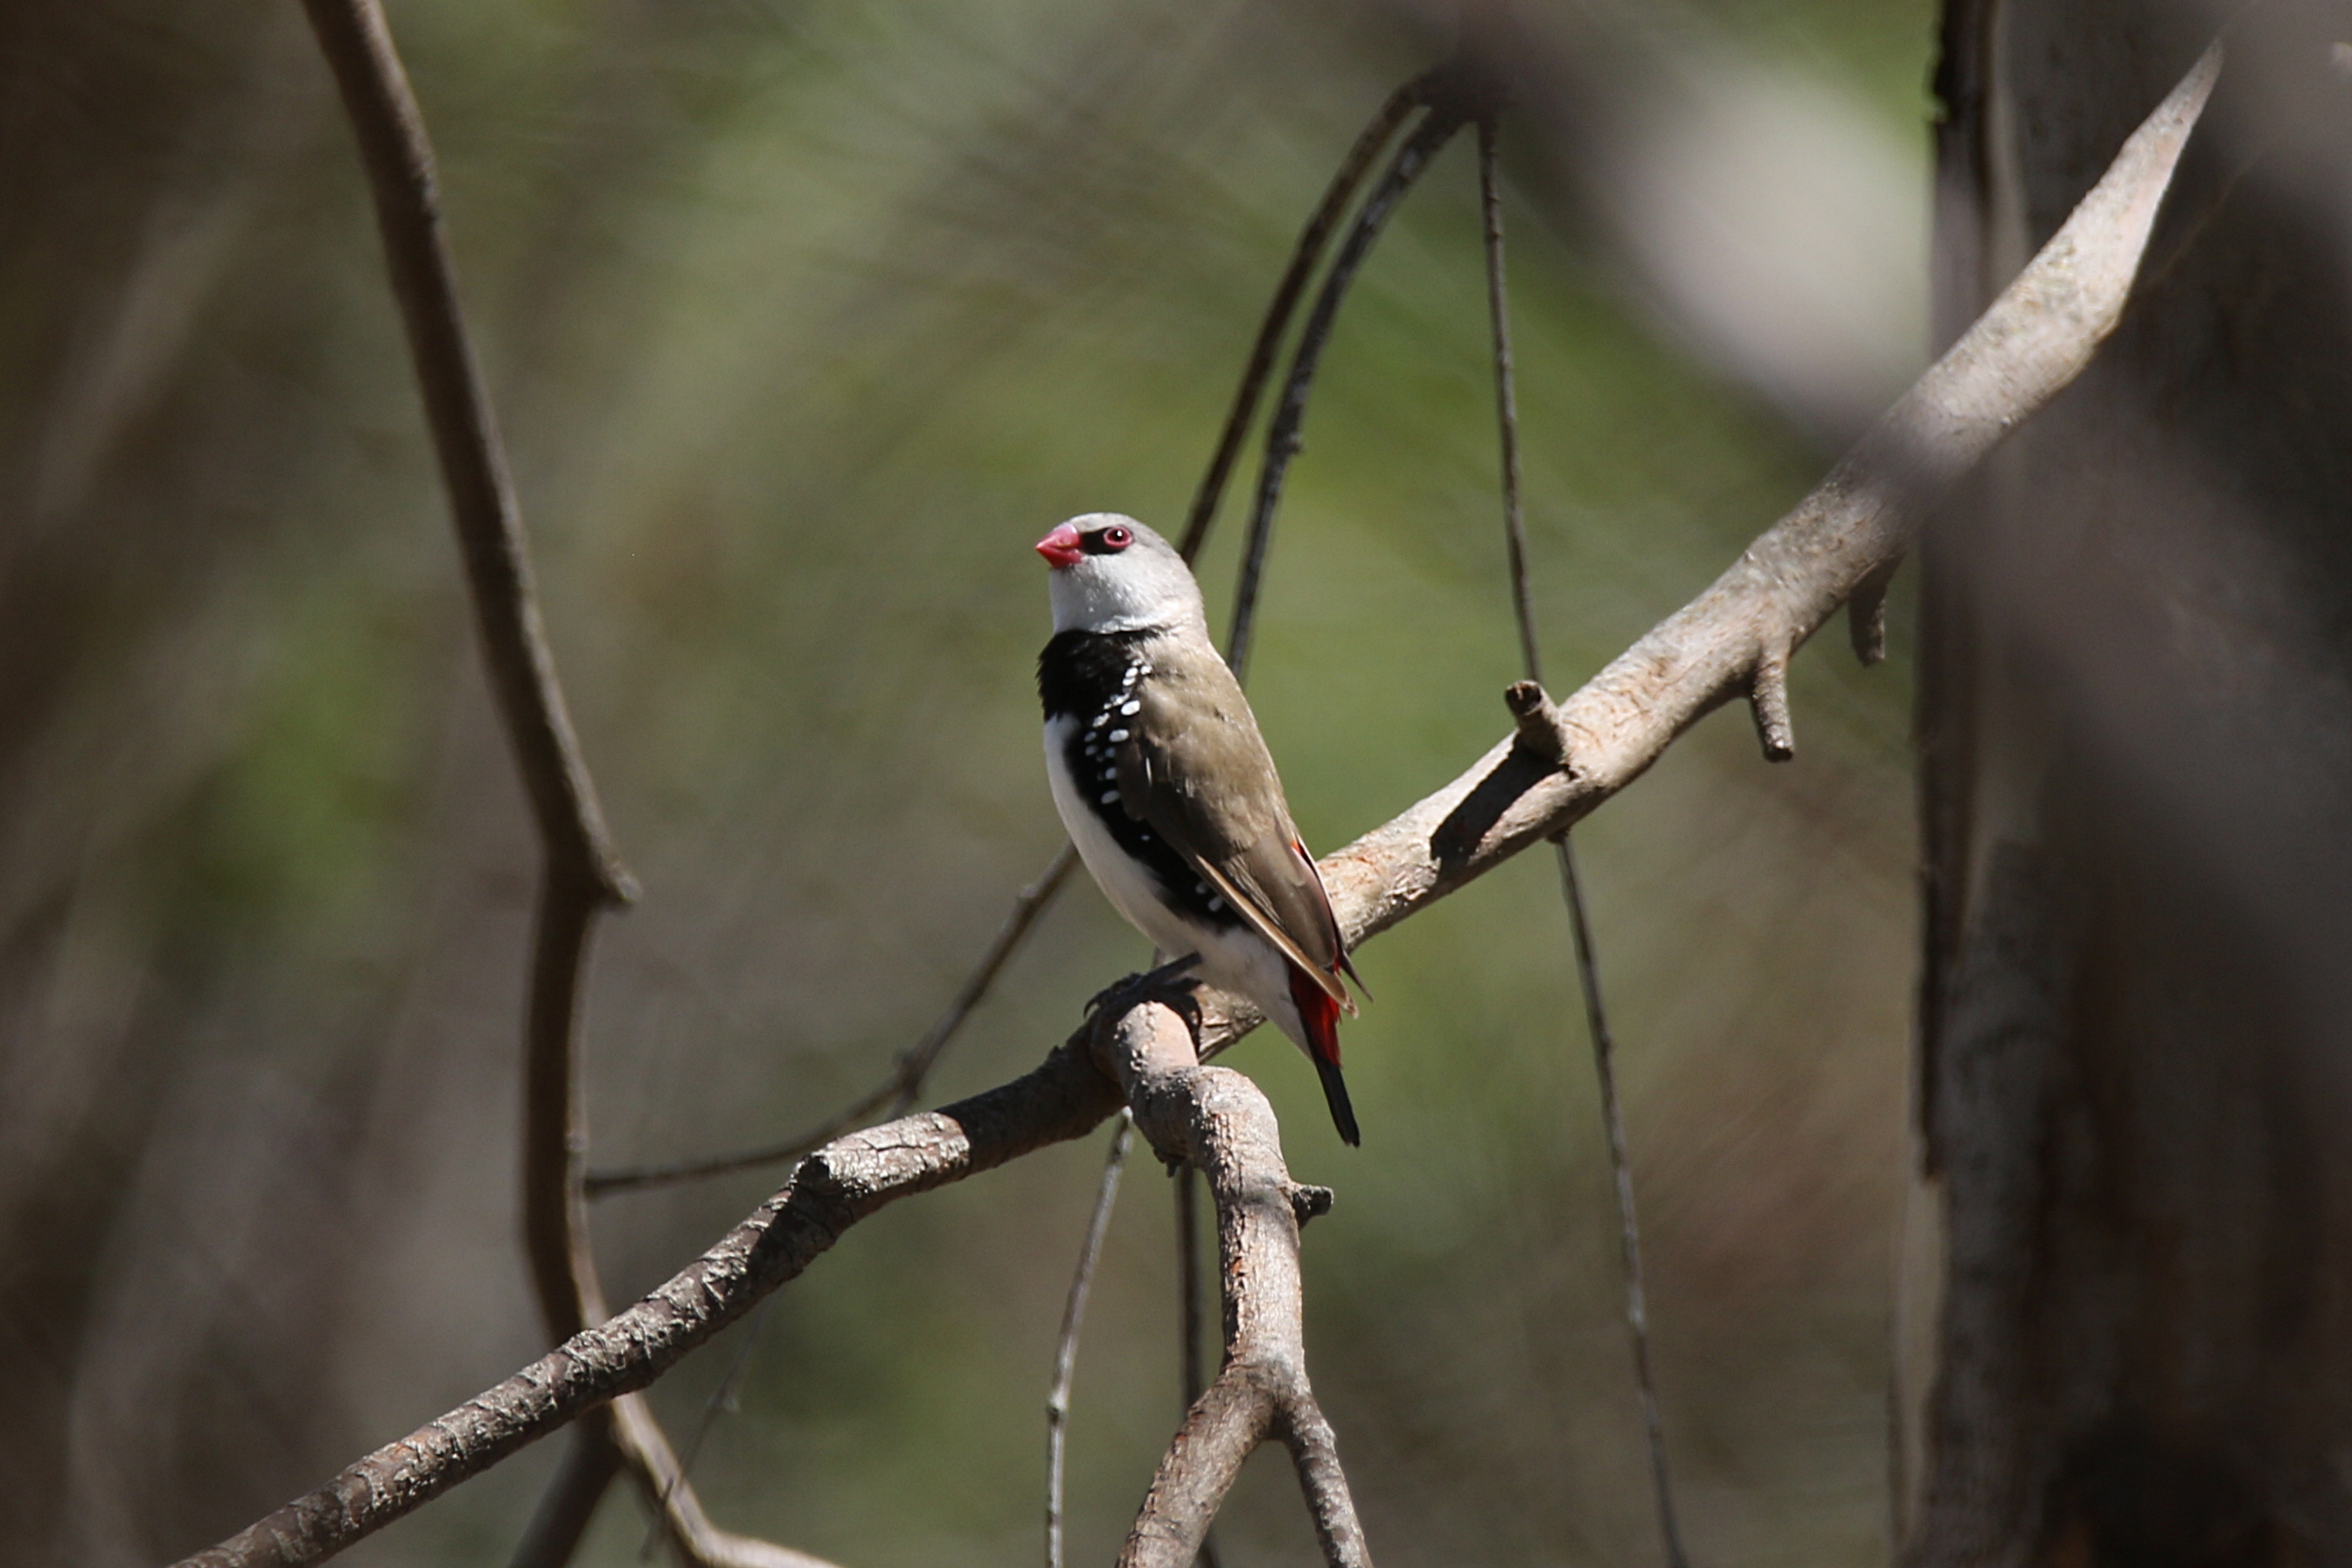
[0,0,1933,1568]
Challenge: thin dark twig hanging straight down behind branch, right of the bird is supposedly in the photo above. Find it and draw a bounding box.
[1477,117,1689,1568]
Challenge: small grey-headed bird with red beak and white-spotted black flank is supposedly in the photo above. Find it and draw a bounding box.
[1037,513,1362,1145]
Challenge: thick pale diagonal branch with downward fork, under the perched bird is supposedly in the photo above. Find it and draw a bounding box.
[186,39,2220,1568]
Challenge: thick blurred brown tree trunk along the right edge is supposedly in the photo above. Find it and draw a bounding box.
[1900,0,2352,1568]
